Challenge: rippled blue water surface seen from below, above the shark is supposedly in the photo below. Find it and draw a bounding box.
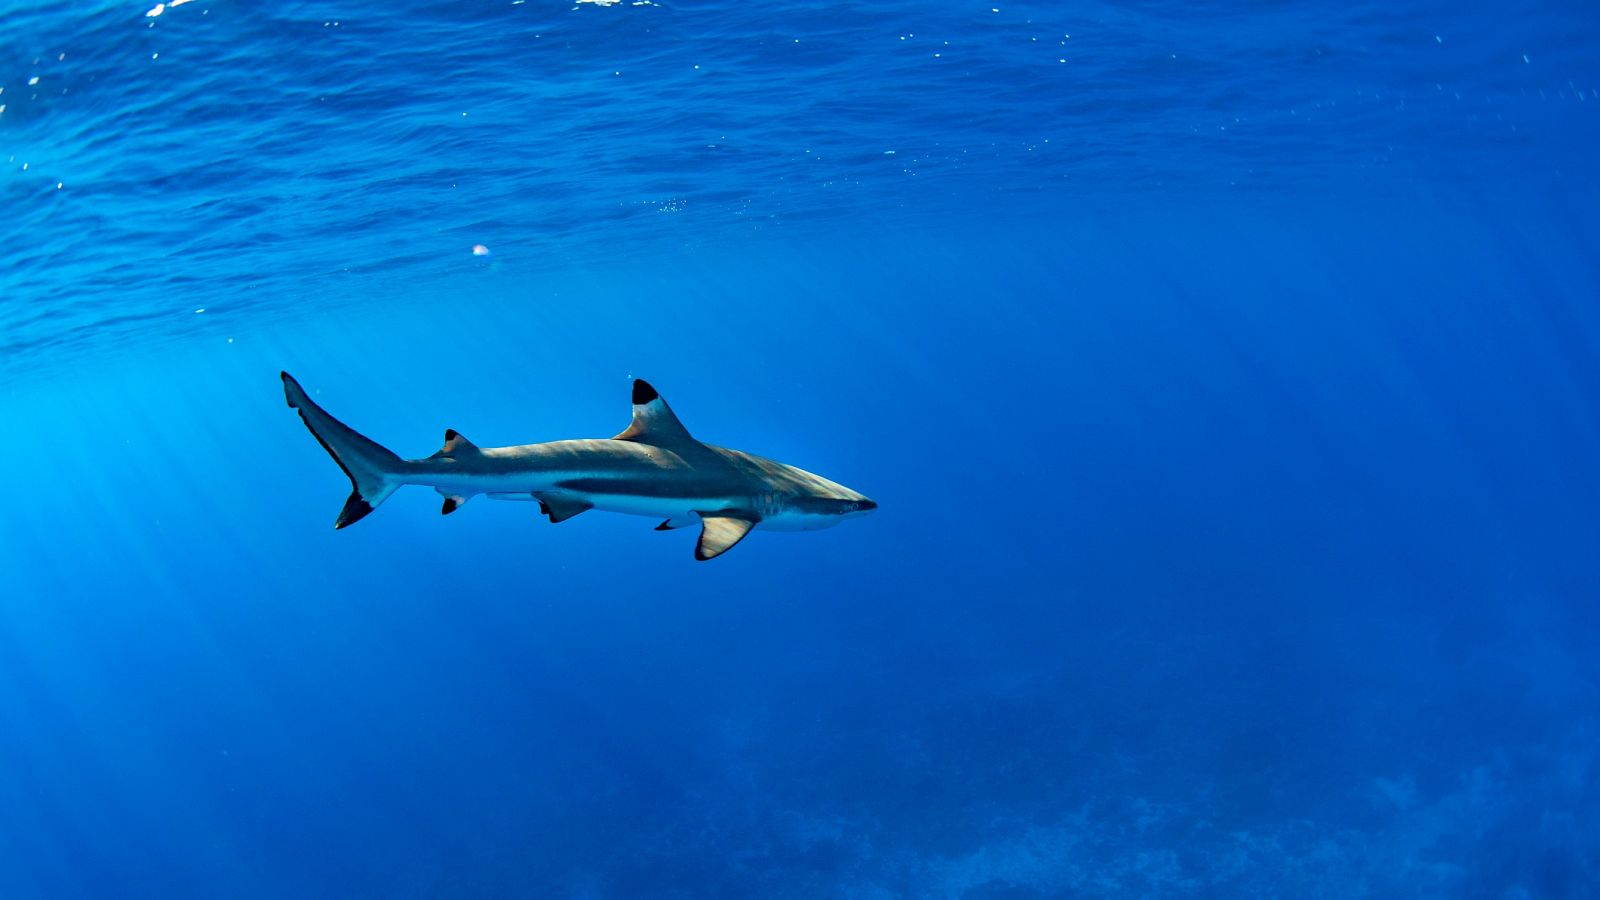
[0,0,1600,371]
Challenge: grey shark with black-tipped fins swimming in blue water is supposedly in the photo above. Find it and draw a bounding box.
[282,372,878,560]
